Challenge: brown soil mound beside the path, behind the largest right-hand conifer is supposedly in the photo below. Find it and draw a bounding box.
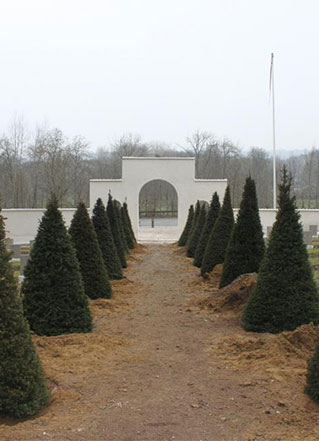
[193,273,257,313]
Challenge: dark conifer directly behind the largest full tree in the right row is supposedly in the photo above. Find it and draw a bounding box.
[219,176,265,288]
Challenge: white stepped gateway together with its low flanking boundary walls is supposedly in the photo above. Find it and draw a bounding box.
[2,157,319,244]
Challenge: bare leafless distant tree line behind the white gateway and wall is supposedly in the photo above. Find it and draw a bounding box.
[0,118,319,210]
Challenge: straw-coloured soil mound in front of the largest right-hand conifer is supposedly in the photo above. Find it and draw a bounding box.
[211,324,319,375]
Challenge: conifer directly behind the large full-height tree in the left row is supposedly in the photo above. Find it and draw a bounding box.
[69,202,112,299]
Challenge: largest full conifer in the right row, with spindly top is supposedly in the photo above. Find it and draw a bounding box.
[243,168,319,333]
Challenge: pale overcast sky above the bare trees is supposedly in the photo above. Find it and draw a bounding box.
[0,0,319,150]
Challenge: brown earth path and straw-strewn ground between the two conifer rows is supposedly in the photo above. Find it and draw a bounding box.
[0,245,319,441]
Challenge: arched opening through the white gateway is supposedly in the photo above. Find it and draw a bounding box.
[139,179,178,228]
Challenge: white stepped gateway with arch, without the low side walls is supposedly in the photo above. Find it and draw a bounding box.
[90,157,227,241]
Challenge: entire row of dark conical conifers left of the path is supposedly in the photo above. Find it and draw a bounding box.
[0,195,136,418]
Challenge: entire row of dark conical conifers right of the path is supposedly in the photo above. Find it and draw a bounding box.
[178,168,319,402]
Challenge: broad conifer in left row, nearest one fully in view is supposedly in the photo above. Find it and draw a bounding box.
[22,197,92,335]
